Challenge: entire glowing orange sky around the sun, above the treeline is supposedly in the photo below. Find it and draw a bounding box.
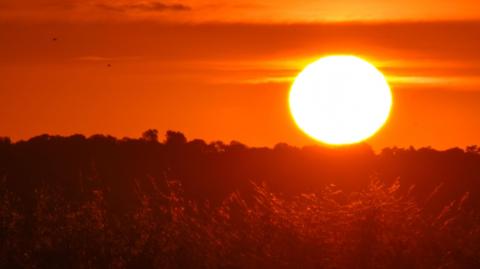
[0,0,480,149]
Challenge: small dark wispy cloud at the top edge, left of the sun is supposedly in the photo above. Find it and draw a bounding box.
[97,1,192,12]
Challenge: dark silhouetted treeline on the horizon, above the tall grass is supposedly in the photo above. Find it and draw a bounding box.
[0,129,480,210]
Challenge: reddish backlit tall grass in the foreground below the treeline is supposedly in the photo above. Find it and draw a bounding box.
[0,177,480,269]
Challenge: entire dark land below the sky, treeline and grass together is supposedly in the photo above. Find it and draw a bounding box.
[0,130,480,269]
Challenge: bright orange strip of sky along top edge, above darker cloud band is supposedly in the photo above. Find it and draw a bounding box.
[0,0,480,22]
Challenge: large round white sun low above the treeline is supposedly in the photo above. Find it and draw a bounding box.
[289,55,392,145]
